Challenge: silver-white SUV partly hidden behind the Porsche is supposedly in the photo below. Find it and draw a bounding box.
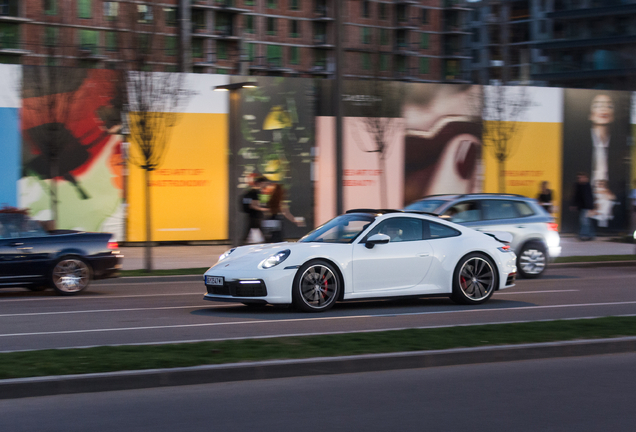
[406,194,561,278]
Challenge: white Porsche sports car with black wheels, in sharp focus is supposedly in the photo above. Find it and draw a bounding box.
[204,209,517,312]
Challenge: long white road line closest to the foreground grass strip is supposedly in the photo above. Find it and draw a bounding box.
[0,301,636,337]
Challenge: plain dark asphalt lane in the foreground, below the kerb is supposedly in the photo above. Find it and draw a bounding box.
[0,353,636,432]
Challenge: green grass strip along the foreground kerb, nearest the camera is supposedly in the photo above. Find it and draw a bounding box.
[0,317,636,379]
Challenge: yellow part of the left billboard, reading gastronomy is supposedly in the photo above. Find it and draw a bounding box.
[127,113,228,242]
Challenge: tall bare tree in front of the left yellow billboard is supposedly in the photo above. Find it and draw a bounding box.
[113,1,188,271]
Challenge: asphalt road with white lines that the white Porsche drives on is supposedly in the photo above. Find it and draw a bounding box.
[0,266,636,351]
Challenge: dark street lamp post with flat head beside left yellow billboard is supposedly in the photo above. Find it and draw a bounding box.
[214,81,257,247]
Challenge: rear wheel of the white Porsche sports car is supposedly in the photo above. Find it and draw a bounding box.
[452,254,497,304]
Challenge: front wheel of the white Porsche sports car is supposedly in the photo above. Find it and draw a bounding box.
[292,261,340,312]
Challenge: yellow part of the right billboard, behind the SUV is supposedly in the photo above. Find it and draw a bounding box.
[483,122,570,221]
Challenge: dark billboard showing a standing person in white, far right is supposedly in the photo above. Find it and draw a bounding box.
[563,89,631,232]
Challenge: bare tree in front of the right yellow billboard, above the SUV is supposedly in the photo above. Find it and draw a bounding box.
[479,85,532,193]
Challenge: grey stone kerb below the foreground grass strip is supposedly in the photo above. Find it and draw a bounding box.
[0,337,636,399]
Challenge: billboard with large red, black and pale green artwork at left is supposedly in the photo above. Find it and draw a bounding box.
[18,66,124,239]
